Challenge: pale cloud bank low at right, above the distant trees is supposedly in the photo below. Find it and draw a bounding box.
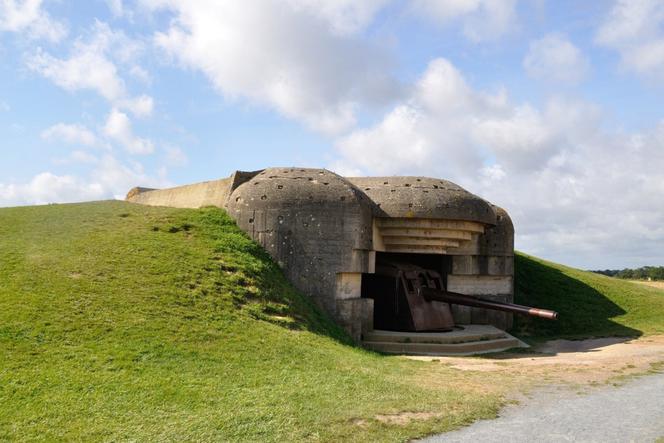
[479,122,664,267]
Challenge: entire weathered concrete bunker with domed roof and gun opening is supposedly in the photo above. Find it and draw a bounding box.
[127,168,552,352]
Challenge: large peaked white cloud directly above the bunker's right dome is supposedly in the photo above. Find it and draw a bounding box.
[335,59,563,178]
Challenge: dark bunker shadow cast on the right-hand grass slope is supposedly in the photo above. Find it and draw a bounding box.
[510,255,643,343]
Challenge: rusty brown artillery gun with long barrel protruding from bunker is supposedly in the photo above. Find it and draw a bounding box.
[368,262,558,332]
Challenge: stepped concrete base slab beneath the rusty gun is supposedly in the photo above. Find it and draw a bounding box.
[362,325,528,356]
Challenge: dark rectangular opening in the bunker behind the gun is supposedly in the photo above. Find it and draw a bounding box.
[362,252,453,331]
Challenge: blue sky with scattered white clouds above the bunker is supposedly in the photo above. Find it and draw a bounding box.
[0,0,664,268]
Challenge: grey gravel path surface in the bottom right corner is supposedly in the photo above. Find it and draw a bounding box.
[420,374,664,443]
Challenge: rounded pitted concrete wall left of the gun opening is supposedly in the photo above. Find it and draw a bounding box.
[227,168,374,338]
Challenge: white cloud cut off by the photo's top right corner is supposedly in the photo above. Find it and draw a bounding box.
[596,0,664,76]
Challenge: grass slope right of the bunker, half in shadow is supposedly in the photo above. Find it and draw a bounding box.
[513,254,664,340]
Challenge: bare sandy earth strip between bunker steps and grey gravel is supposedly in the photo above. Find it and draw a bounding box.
[411,335,664,386]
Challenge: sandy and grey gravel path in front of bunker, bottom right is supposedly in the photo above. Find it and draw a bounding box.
[414,336,664,442]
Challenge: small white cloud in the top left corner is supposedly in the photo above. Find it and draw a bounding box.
[0,0,67,42]
